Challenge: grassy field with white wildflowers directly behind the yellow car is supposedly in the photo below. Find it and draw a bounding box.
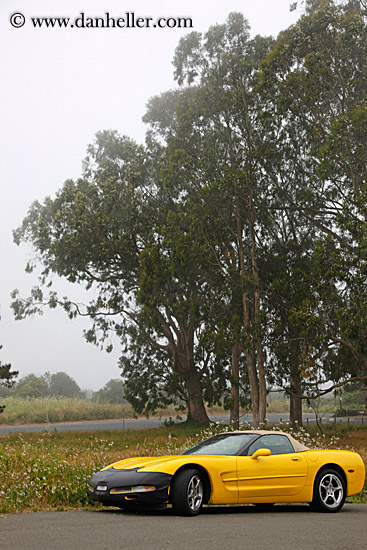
[0,426,367,513]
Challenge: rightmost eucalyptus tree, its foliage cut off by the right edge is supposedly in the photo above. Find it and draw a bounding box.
[261,0,367,398]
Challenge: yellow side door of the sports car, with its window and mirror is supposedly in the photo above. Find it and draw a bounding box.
[237,434,307,502]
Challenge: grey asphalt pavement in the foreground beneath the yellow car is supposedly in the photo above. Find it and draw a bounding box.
[0,504,367,550]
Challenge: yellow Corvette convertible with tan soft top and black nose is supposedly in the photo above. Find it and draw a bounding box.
[88,430,365,516]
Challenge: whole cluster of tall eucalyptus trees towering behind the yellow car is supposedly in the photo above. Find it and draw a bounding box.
[13,0,367,426]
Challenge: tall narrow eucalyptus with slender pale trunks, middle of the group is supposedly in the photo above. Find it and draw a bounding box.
[158,13,272,426]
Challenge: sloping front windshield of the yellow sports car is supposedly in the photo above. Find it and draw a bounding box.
[182,433,257,456]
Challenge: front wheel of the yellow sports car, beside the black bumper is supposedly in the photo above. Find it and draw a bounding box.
[171,470,204,516]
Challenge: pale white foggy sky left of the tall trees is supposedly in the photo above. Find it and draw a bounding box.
[0,0,299,390]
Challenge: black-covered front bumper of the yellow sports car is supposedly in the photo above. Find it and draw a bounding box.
[88,468,172,508]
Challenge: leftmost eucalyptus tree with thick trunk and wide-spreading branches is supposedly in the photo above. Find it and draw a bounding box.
[13,132,230,430]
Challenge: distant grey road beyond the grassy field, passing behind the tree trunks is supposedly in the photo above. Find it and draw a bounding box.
[0,413,352,435]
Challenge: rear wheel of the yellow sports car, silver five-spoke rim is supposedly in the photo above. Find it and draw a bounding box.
[311,469,346,512]
